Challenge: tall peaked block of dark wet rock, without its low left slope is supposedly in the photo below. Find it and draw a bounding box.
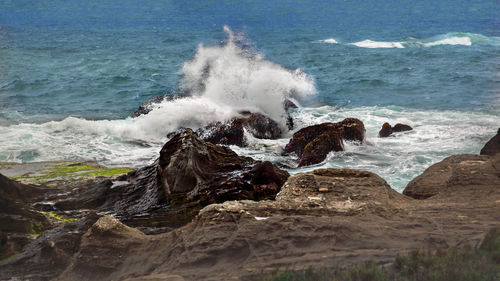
[158,129,288,207]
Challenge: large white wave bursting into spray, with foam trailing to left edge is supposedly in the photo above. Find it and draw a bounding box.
[0,27,316,164]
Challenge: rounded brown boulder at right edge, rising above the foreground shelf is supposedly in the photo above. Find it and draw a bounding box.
[403,154,500,199]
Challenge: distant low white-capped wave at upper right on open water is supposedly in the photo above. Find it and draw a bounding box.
[349,32,500,48]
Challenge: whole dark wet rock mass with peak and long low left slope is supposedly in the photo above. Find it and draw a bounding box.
[48,129,289,229]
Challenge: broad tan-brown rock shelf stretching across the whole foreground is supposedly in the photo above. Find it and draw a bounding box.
[0,151,500,280]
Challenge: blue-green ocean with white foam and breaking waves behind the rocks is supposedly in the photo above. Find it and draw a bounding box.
[0,0,500,191]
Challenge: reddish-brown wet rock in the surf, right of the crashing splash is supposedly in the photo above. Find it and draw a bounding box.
[285,118,365,167]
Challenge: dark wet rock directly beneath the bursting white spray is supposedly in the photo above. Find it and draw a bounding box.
[197,111,281,146]
